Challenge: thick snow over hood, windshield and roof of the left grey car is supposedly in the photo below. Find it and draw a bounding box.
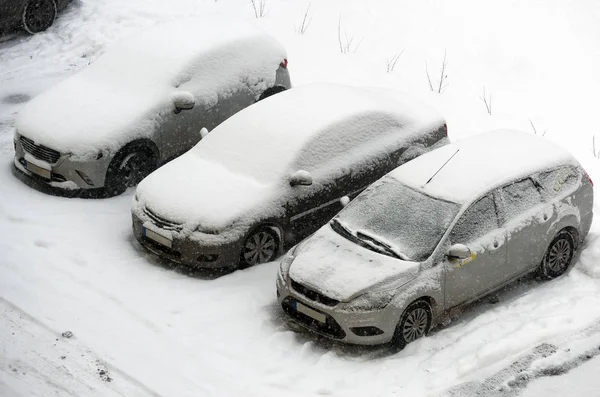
[16,18,286,154]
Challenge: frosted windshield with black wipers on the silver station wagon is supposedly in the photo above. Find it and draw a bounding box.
[331,180,460,262]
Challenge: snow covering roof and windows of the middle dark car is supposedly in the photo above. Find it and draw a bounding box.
[192,83,444,182]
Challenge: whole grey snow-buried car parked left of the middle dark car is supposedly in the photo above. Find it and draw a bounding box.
[14,18,291,195]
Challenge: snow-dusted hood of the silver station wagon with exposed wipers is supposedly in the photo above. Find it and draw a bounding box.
[289,225,419,302]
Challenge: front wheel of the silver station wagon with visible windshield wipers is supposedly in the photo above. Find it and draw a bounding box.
[392,300,432,350]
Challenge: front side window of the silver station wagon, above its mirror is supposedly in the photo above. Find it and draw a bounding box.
[450,194,498,244]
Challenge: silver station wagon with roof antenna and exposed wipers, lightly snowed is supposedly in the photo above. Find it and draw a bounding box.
[276,131,593,348]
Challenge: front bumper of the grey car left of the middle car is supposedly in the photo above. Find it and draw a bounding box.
[13,136,110,190]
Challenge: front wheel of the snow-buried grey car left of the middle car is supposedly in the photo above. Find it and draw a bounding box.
[104,144,158,197]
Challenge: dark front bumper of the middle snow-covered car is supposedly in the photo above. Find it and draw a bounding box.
[131,206,242,269]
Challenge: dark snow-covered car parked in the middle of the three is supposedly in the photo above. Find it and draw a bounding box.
[132,84,447,267]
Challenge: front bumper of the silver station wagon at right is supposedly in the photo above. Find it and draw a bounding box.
[276,272,399,345]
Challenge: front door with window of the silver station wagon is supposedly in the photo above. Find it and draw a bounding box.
[444,193,506,308]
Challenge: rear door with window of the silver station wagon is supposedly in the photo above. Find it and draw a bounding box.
[500,178,555,277]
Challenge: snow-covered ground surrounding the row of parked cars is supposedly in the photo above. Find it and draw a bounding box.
[0,0,600,397]
